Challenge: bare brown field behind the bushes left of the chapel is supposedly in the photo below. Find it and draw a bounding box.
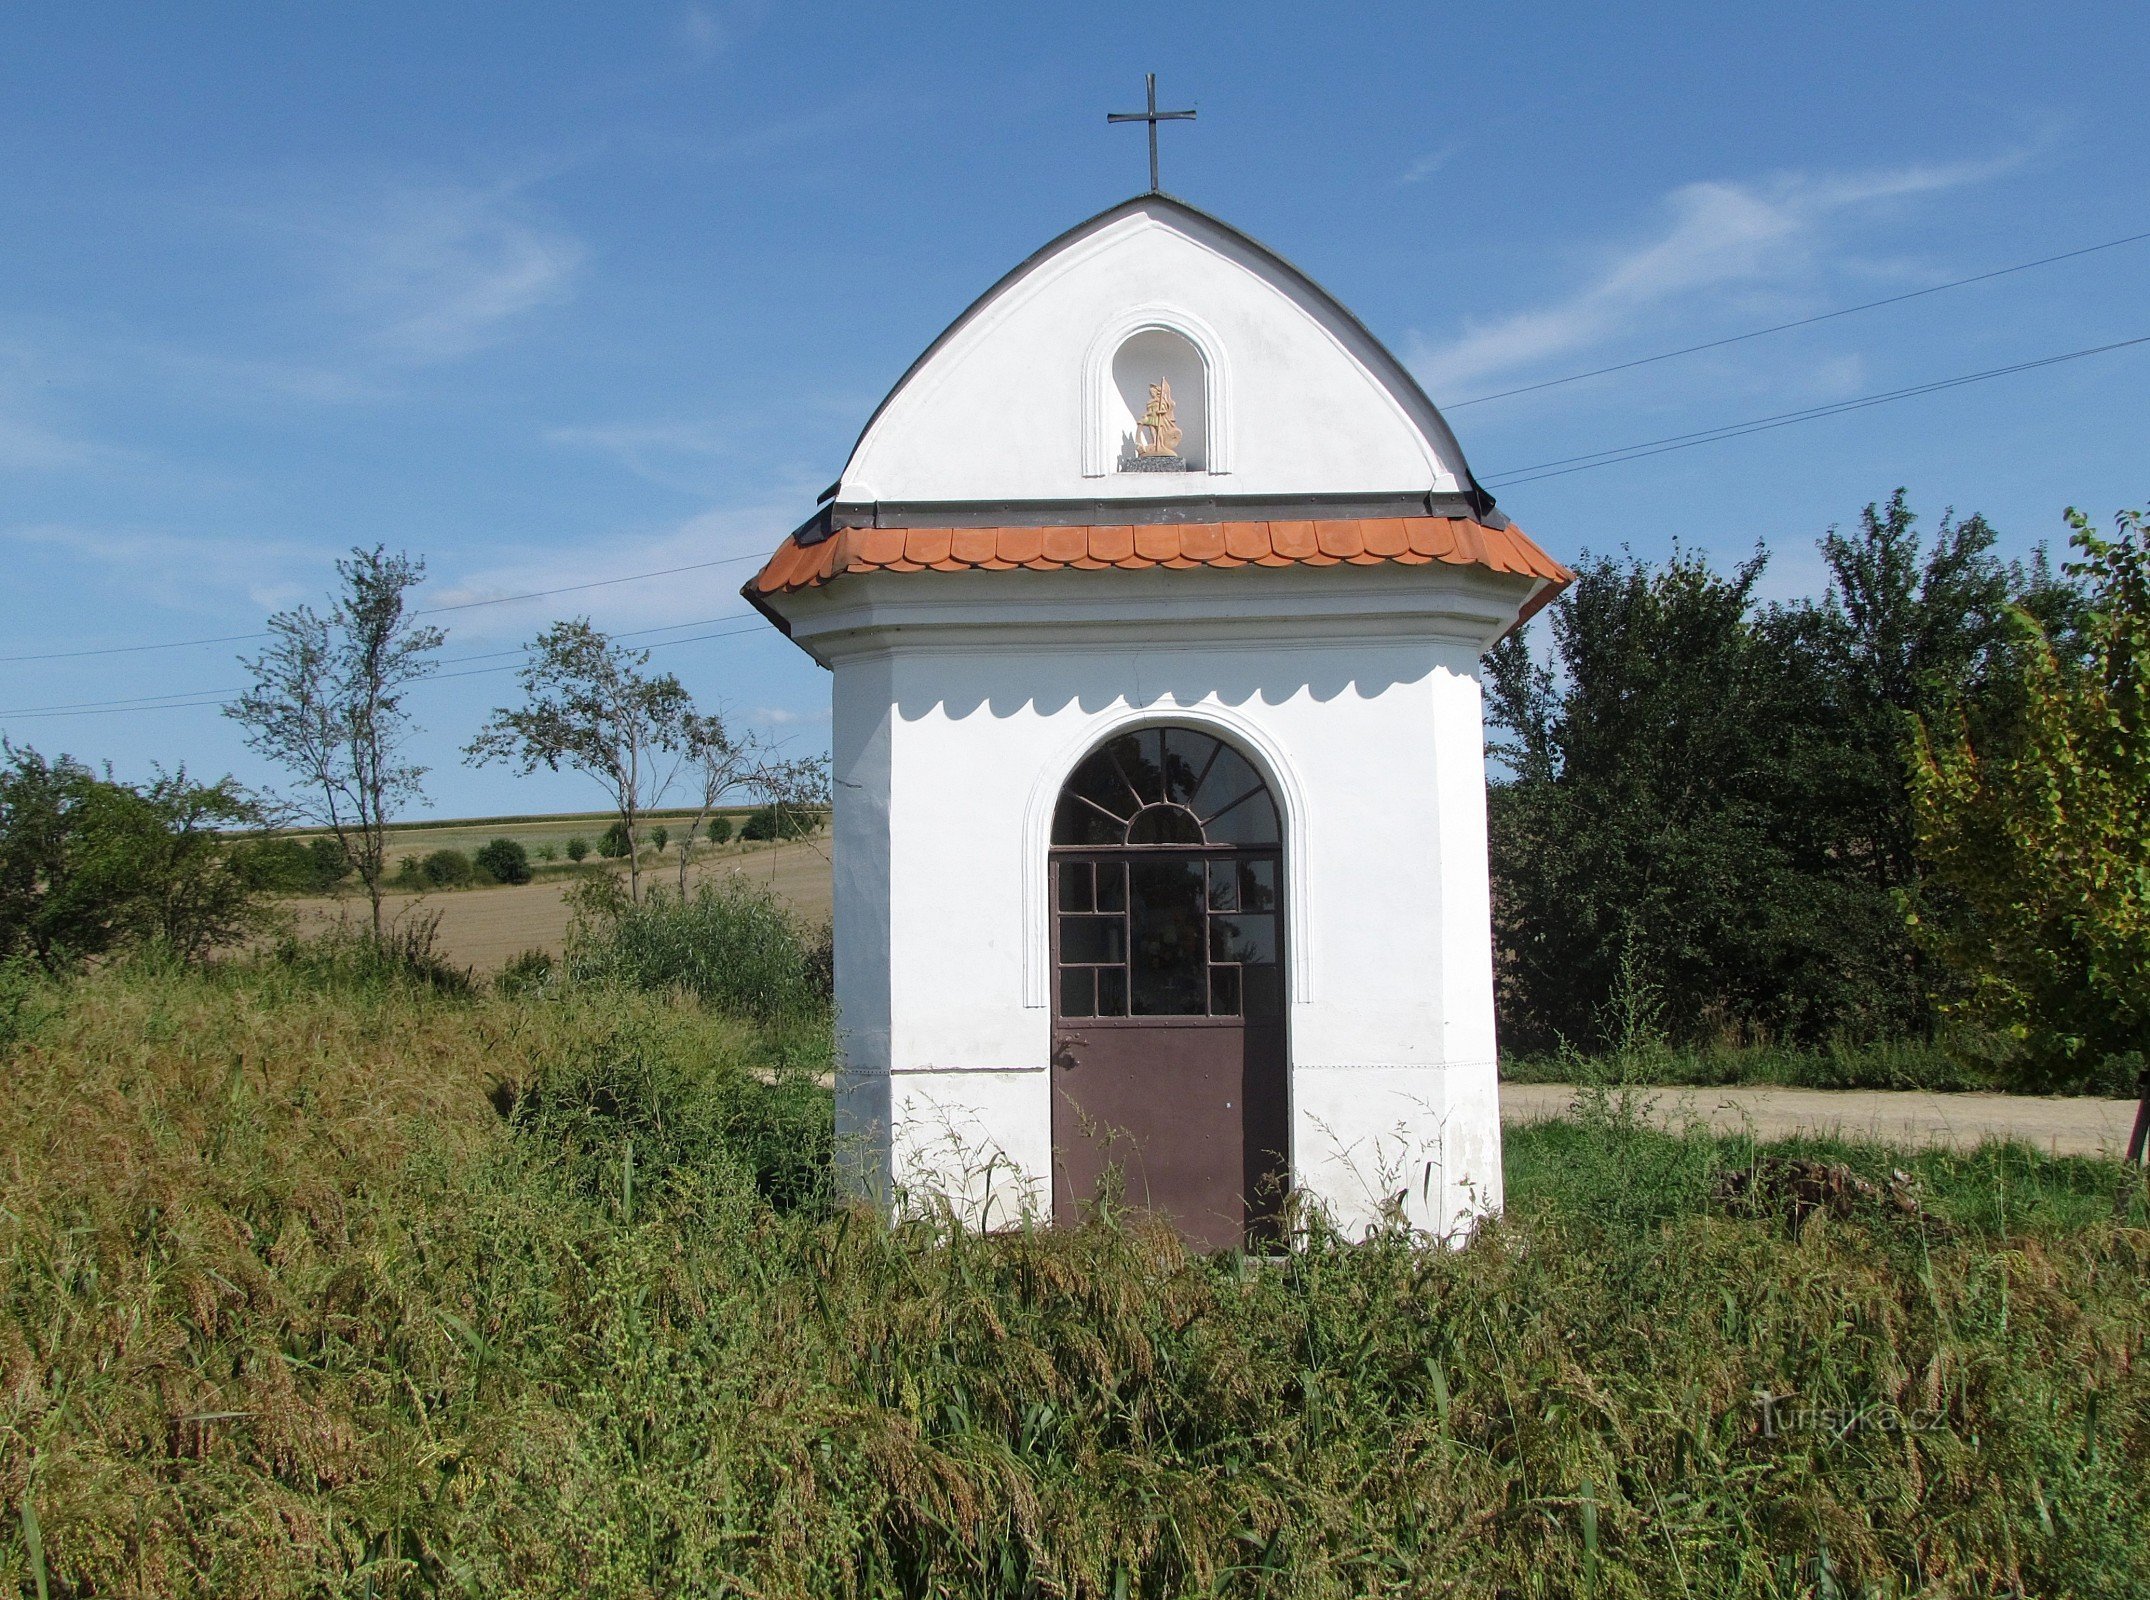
[290,839,830,972]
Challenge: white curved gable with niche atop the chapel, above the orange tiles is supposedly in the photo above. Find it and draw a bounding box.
[836,194,1490,503]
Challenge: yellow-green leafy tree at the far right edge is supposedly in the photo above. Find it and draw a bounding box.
[1909,510,2150,1103]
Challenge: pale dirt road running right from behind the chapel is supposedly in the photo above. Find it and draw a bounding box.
[1501,1084,2135,1157]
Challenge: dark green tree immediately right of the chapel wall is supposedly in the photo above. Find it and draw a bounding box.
[1488,553,1890,1045]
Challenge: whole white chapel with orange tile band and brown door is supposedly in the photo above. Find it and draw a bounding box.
[746,191,1570,1247]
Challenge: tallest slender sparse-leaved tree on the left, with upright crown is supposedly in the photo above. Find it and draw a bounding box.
[224,544,447,938]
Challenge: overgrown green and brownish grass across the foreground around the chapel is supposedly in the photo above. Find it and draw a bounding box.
[0,944,2150,1600]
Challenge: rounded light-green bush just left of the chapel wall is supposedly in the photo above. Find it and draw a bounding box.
[568,875,830,1022]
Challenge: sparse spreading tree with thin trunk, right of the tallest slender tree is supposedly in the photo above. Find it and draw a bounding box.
[464,617,694,901]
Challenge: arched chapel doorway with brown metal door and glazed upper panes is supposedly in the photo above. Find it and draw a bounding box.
[1051,727,1290,1249]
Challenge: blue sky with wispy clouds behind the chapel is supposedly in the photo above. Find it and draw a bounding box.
[0,2,2150,815]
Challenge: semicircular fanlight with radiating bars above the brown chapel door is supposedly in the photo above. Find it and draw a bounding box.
[1054,727,1277,849]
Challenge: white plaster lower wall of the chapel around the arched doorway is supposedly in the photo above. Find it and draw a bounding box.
[787,568,1527,1234]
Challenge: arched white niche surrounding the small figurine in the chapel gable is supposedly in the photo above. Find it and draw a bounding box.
[1081,305,1232,475]
